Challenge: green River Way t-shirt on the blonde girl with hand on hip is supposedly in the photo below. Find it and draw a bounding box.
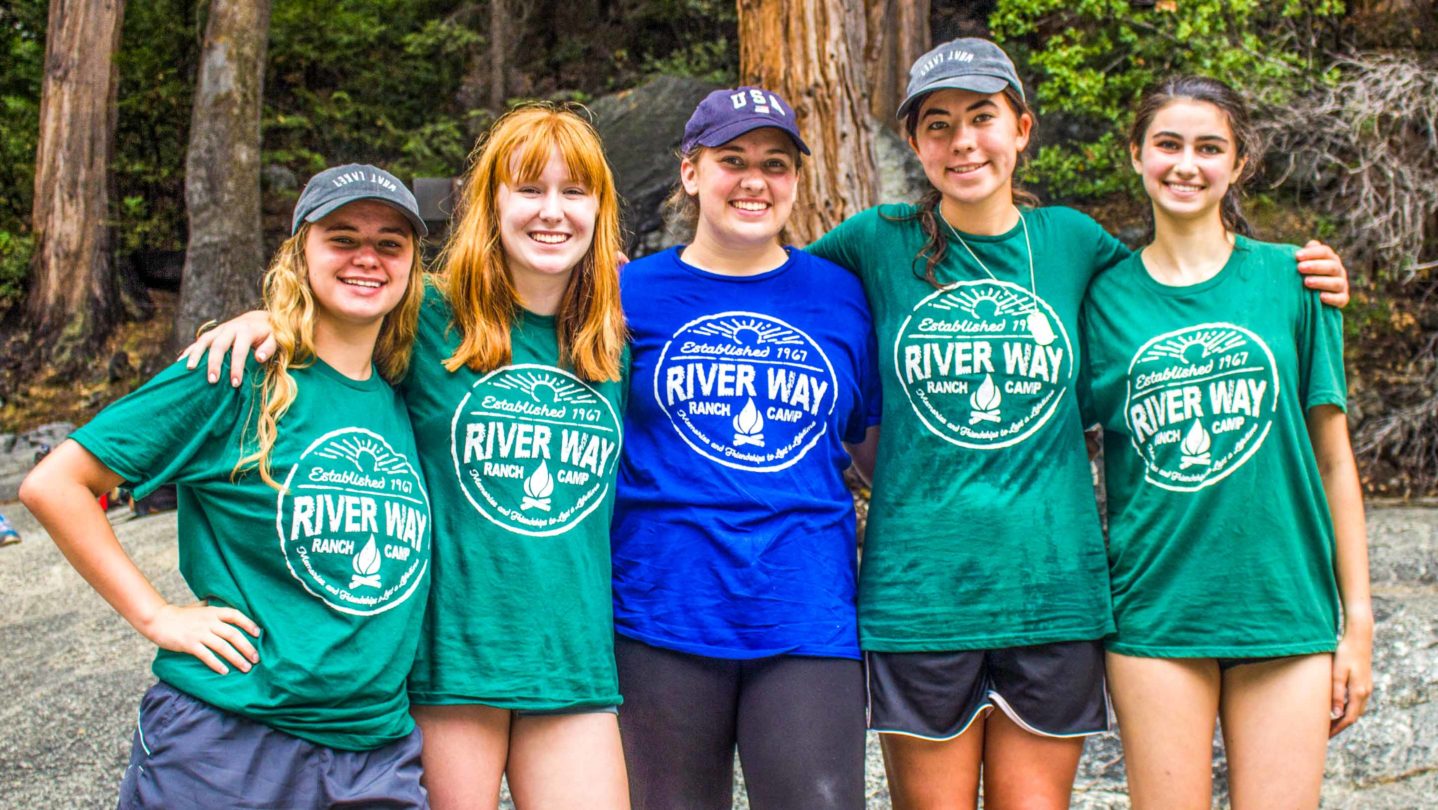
[70,360,430,751]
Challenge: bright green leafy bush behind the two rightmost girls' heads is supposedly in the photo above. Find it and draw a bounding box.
[989,0,1343,199]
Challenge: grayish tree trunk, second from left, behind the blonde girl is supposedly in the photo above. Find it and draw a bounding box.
[174,0,270,344]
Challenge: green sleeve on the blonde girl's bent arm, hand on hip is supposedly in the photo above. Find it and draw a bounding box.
[70,361,255,498]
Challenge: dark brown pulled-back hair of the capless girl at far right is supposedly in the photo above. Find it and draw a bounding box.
[1129,76,1263,236]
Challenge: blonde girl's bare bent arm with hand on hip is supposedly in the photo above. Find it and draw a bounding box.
[20,440,260,675]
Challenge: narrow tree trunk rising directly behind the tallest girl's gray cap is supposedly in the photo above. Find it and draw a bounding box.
[864,0,930,132]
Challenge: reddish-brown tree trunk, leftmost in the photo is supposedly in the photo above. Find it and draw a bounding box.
[26,0,125,371]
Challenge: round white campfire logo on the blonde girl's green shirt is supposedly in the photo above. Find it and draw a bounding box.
[275,427,430,616]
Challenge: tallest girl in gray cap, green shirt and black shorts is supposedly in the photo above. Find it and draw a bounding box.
[810,39,1346,809]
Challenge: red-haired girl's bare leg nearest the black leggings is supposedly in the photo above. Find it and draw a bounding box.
[509,712,630,810]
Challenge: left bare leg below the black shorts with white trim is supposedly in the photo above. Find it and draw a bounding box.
[879,719,984,810]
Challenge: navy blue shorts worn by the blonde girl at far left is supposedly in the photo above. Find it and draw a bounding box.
[119,682,430,810]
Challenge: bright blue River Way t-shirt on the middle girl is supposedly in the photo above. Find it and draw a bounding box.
[613,247,880,659]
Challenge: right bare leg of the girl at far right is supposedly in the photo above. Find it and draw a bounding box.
[1221,653,1333,810]
